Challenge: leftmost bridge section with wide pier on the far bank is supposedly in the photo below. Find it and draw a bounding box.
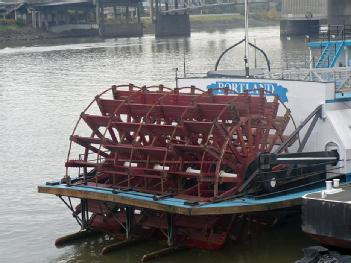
[3,0,143,37]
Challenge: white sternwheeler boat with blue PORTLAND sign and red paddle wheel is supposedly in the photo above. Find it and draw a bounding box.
[38,2,351,260]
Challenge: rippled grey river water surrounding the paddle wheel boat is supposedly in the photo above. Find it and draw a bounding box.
[0,27,313,263]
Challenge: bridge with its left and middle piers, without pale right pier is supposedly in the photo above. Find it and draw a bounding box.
[4,0,277,37]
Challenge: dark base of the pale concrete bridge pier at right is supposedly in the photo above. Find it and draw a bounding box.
[280,20,319,36]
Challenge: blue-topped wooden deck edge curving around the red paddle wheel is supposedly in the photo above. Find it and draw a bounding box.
[38,184,319,216]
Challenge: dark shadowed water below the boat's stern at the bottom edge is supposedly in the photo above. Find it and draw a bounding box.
[51,218,314,263]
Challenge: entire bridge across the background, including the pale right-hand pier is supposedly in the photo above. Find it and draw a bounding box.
[0,0,351,37]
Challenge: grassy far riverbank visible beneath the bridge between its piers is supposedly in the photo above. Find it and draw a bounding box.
[0,14,279,46]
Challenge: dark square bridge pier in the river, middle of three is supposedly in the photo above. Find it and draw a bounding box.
[155,13,190,37]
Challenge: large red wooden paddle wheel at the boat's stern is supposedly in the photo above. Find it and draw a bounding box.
[66,84,290,248]
